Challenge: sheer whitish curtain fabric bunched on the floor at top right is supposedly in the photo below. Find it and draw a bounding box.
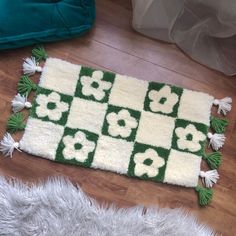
[132,0,236,75]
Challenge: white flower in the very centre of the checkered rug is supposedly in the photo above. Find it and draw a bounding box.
[106,109,138,138]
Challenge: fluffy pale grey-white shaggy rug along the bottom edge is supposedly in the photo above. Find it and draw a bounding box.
[0,178,215,236]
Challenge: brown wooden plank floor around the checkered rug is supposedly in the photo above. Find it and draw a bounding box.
[0,0,236,235]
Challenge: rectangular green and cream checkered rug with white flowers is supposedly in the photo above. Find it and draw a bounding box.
[2,47,232,205]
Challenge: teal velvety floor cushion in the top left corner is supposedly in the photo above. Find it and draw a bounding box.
[0,0,95,50]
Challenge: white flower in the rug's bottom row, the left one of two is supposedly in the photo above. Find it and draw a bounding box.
[63,131,95,162]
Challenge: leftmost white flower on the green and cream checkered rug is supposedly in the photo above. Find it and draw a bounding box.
[36,92,69,121]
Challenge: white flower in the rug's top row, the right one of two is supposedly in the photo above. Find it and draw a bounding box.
[148,85,178,114]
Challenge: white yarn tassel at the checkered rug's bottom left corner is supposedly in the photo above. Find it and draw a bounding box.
[0,133,21,158]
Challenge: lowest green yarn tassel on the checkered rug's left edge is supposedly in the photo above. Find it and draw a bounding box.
[7,113,25,133]
